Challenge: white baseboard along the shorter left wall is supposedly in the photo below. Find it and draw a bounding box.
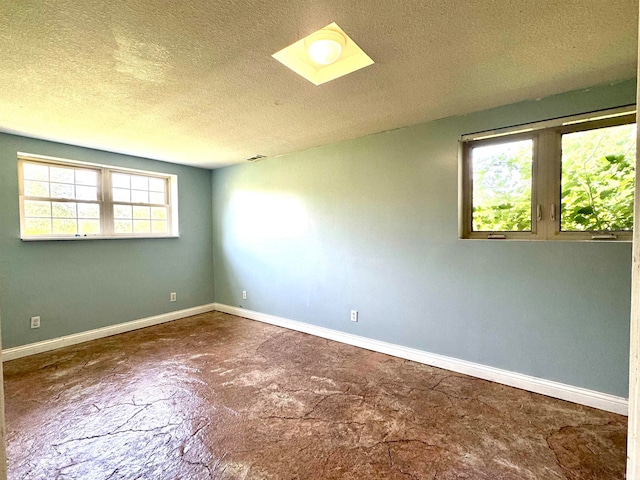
[2,303,215,362]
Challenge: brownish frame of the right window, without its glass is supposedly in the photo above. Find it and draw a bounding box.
[458,105,638,241]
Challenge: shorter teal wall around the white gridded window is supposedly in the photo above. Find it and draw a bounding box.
[0,134,213,348]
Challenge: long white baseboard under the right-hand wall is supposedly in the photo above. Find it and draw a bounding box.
[215,303,629,415]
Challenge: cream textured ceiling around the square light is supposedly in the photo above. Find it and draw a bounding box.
[0,0,638,168]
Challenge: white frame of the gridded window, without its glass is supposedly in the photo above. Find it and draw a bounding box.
[18,152,180,241]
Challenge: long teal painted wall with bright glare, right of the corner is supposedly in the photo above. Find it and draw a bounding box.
[212,80,635,396]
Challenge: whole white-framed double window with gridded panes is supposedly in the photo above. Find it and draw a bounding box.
[18,153,178,240]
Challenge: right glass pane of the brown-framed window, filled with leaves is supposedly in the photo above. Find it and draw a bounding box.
[560,124,636,231]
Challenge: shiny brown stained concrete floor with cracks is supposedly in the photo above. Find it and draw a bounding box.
[5,313,626,480]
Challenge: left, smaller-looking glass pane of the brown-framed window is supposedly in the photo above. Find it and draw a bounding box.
[471,139,533,232]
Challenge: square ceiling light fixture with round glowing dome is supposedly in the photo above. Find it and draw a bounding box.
[272,22,373,85]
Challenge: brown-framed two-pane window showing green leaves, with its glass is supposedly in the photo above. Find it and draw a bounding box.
[460,106,636,240]
